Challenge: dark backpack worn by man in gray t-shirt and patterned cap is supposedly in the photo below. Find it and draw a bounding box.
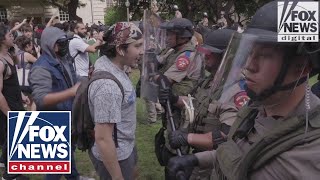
[71,71,124,151]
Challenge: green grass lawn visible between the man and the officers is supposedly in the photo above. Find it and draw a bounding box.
[0,70,164,180]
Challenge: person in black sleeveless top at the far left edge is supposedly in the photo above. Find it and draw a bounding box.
[0,25,29,180]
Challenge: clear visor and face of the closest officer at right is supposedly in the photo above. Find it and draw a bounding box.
[214,33,307,105]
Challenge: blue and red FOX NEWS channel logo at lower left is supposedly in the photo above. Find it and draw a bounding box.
[8,111,71,174]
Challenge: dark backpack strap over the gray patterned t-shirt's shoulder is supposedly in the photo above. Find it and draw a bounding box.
[87,71,125,147]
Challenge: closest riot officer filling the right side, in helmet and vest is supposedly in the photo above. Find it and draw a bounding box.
[169,1,320,180]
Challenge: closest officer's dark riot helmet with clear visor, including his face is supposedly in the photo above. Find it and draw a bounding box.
[211,1,320,105]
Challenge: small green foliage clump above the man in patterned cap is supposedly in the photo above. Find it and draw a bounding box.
[104,6,127,26]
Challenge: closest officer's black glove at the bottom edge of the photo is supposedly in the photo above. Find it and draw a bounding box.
[168,154,199,179]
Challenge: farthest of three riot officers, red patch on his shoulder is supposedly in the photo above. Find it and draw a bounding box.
[155,18,204,179]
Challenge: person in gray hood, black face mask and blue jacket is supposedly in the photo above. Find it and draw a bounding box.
[29,27,79,180]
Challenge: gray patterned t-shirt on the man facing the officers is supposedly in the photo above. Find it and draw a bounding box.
[88,56,136,160]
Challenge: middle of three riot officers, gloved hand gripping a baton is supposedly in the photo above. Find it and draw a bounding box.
[159,29,249,179]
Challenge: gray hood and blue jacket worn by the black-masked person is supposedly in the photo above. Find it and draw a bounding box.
[29,27,75,110]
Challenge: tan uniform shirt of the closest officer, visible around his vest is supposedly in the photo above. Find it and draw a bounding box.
[196,94,320,180]
